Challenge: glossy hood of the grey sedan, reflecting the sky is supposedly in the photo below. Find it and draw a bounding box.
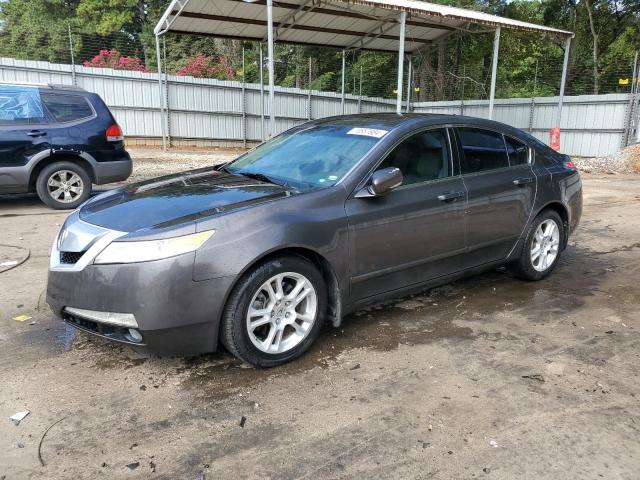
[79,167,292,232]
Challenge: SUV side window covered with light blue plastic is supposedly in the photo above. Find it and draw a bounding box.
[0,85,45,125]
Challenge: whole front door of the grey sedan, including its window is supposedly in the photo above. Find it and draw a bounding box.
[345,128,467,300]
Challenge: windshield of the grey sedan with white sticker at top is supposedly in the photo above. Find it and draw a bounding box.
[225,125,387,189]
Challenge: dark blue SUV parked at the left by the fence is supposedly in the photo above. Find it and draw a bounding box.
[0,83,132,209]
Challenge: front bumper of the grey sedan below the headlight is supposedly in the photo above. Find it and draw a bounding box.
[47,253,235,355]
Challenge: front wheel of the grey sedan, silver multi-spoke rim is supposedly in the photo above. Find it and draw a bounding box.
[220,255,327,367]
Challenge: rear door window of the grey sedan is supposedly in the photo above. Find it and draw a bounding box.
[458,127,509,174]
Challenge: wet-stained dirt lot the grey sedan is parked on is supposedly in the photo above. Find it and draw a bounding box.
[0,157,640,480]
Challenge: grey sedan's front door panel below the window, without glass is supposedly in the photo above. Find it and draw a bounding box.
[346,177,466,300]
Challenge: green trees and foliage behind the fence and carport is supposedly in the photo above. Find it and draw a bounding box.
[0,0,640,100]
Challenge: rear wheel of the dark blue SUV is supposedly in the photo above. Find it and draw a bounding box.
[36,161,91,210]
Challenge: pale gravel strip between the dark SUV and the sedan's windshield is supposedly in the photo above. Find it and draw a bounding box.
[127,148,244,183]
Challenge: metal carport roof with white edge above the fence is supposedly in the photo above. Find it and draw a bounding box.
[155,0,573,52]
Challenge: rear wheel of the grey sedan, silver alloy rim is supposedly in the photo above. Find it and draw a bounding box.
[511,210,564,281]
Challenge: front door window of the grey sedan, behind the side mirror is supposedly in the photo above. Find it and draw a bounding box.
[379,129,451,185]
